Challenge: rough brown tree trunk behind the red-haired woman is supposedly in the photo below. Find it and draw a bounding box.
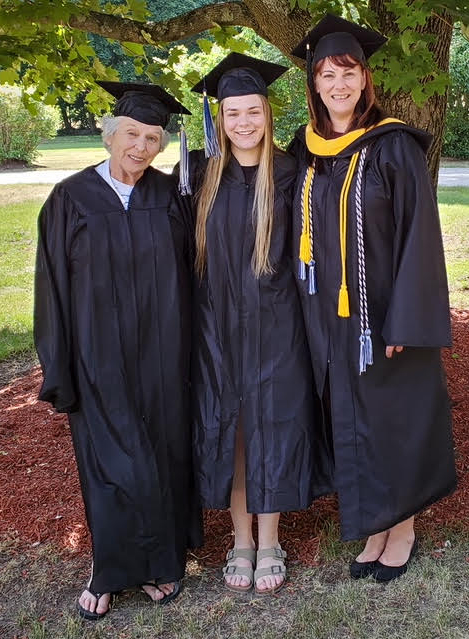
[370,0,453,186]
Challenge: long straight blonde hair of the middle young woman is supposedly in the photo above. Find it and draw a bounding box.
[195,95,274,278]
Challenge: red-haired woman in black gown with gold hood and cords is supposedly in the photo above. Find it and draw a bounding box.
[289,15,456,582]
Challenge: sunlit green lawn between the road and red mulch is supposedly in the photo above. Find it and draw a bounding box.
[0,185,469,360]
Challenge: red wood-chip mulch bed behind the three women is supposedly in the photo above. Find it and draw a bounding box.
[0,310,469,565]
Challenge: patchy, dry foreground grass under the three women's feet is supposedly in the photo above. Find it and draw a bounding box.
[0,533,469,639]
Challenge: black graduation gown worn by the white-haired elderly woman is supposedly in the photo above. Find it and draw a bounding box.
[35,167,201,592]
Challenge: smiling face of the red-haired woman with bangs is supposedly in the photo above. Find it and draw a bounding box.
[314,58,366,133]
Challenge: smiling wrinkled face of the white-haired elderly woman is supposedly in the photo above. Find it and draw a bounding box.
[106,116,163,185]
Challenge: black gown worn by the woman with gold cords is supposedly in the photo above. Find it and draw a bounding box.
[289,123,456,540]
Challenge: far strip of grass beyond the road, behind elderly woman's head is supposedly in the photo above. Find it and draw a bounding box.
[34,135,179,170]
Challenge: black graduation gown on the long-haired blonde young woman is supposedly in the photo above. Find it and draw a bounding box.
[186,152,326,513]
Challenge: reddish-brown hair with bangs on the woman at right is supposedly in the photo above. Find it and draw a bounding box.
[307,53,386,139]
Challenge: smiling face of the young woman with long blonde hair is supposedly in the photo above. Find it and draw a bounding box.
[222,94,266,166]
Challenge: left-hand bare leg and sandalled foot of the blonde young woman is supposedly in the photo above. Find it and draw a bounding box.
[225,423,255,587]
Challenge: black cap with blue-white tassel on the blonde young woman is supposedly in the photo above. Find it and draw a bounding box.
[192,53,288,157]
